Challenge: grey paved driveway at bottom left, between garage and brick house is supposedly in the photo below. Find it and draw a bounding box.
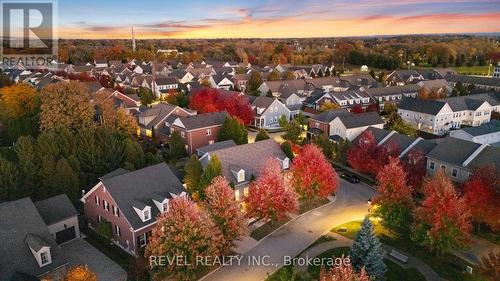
[61,239,127,281]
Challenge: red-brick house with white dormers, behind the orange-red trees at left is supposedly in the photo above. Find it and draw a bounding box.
[81,163,186,255]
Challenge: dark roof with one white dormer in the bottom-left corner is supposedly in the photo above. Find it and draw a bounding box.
[0,197,67,281]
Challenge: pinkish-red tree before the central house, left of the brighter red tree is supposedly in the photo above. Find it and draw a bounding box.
[244,158,298,220]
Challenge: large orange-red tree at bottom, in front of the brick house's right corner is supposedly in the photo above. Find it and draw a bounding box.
[145,196,223,280]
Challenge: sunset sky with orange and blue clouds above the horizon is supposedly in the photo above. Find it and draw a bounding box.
[58,0,500,39]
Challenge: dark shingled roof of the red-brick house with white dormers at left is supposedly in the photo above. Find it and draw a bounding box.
[101,162,185,229]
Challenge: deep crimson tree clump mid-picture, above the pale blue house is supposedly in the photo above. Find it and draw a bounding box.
[189,88,255,124]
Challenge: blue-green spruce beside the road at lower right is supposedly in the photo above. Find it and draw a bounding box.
[350,217,386,280]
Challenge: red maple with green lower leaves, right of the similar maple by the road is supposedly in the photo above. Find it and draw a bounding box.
[412,171,471,253]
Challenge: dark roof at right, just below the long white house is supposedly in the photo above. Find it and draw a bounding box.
[427,137,481,166]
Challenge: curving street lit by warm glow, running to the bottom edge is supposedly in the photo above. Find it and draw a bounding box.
[203,180,374,281]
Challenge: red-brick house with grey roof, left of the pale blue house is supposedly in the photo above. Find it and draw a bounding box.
[170,111,227,154]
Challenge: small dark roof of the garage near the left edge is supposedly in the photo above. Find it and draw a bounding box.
[35,194,78,225]
